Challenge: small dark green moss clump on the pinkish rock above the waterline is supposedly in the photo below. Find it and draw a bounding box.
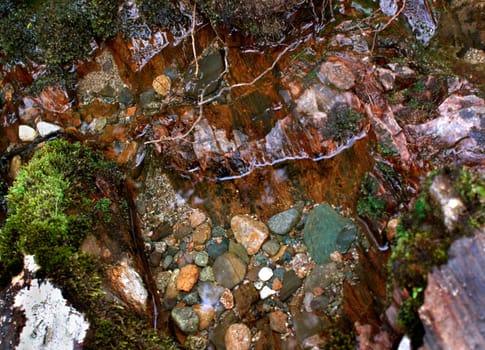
[324,103,364,142]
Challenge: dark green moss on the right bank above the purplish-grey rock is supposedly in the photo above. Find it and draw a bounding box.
[389,167,485,347]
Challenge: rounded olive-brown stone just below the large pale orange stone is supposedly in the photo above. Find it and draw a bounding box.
[212,253,246,289]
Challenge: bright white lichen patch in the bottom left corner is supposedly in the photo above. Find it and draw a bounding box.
[14,276,89,350]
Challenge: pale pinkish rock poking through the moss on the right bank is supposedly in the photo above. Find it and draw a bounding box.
[429,174,466,232]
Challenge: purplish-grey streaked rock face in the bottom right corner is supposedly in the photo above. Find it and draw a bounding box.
[419,229,485,350]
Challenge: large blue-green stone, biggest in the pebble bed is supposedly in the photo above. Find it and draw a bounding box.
[303,203,357,264]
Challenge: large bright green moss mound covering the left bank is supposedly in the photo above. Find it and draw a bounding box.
[0,140,173,349]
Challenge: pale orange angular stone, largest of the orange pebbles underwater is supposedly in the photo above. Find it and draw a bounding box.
[231,215,269,255]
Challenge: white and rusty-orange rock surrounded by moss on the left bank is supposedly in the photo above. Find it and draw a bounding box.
[107,260,148,313]
